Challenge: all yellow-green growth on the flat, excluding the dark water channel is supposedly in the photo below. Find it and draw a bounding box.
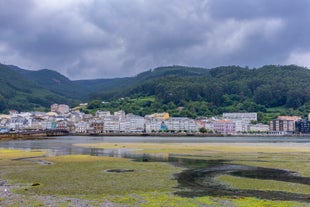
[0,143,310,207]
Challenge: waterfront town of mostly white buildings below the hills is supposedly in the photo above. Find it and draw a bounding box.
[0,104,310,135]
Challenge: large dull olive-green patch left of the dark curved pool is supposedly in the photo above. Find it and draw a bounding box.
[6,155,179,198]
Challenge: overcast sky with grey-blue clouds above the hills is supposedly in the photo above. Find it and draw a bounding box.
[0,0,310,80]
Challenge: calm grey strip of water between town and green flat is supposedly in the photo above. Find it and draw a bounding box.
[0,136,310,155]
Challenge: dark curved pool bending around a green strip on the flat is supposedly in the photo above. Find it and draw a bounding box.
[175,160,310,203]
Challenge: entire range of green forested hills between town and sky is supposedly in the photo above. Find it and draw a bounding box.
[0,65,310,117]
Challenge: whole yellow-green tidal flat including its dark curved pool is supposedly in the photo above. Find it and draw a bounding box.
[0,143,310,206]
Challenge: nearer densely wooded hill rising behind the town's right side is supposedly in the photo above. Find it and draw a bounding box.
[85,65,310,120]
